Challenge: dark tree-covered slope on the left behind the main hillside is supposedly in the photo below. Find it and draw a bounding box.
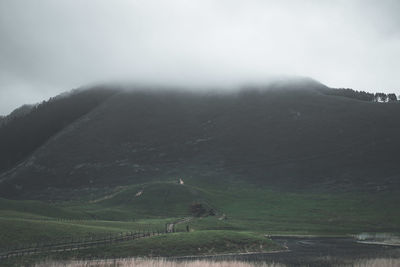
[0,89,114,174]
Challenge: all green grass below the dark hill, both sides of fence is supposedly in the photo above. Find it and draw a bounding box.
[0,181,400,263]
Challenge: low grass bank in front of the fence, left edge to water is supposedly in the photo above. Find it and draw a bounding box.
[3,231,283,266]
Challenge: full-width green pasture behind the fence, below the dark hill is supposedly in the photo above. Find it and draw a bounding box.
[0,183,400,251]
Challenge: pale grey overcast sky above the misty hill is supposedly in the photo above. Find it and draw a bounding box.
[0,0,400,115]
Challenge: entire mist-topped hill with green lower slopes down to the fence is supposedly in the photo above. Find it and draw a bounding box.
[0,80,400,264]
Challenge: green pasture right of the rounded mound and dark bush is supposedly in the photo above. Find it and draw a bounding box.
[183,183,400,235]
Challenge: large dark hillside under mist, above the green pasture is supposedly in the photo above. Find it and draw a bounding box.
[0,83,400,199]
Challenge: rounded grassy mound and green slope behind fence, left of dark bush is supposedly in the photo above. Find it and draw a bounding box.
[0,182,206,249]
